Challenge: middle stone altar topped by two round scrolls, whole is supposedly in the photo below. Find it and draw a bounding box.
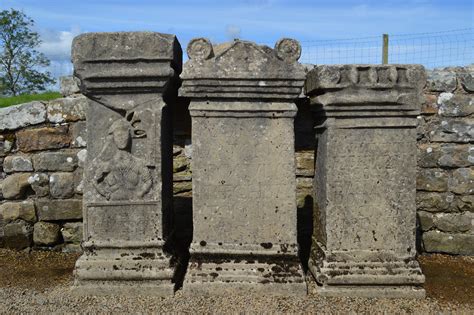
[180,38,306,294]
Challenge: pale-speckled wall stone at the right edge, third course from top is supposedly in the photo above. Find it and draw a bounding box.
[430,118,474,143]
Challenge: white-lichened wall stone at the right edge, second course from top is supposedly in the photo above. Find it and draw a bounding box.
[438,93,474,117]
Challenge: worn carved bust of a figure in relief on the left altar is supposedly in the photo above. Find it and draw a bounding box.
[93,115,153,200]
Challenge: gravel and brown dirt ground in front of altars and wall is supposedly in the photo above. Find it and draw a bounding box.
[0,249,474,314]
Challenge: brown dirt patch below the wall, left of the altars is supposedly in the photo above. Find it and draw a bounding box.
[0,249,80,290]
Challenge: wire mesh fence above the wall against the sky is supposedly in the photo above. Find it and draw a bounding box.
[300,28,474,68]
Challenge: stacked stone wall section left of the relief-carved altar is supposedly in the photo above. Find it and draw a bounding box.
[0,78,87,251]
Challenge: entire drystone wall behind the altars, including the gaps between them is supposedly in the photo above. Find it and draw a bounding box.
[0,65,474,256]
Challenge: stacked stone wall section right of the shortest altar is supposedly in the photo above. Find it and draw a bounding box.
[417,66,474,255]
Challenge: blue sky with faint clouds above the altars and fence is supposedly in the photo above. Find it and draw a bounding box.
[0,0,474,79]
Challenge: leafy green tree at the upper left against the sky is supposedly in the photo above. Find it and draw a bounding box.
[0,9,55,95]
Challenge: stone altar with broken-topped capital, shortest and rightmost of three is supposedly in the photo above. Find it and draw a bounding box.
[305,65,425,298]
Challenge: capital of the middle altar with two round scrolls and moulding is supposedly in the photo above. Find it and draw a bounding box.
[180,38,306,100]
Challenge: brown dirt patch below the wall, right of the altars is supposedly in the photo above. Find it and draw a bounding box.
[418,254,474,304]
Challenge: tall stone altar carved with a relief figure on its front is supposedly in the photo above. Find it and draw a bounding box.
[72,32,182,295]
